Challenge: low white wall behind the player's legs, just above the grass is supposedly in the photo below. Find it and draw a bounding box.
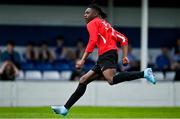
[0,80,180,106]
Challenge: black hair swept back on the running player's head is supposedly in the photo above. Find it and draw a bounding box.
[89,3,107,19]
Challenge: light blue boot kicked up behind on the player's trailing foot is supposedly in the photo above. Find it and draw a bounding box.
[144,68,156,84]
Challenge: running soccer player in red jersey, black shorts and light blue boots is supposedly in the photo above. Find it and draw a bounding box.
[51,4,156,116]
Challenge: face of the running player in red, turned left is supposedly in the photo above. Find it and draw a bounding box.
[84,8,97,23]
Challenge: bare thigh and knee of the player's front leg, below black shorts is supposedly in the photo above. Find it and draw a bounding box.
[79,70,97,84]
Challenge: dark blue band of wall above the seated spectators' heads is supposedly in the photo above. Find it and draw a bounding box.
[0,25,180,48]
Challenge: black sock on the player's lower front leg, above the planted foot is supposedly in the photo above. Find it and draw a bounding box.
[64,83,87,109]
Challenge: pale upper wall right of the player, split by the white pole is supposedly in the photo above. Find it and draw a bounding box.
[114,8,180,27]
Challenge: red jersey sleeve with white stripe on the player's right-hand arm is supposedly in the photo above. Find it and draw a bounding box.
[116,31,128,46]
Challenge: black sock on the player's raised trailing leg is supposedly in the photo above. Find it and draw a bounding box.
[113,72,144,84]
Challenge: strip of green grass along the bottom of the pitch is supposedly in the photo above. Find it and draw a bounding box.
[0,107,180,119]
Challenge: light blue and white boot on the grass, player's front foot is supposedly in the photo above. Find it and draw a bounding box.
[51,106,69,116]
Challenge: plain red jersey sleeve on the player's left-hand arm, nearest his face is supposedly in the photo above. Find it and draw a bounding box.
[85,22,98,53]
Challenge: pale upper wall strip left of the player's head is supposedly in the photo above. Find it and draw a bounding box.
[0,5,85,25]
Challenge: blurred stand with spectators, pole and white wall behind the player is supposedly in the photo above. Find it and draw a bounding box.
[0,0,180,106]
